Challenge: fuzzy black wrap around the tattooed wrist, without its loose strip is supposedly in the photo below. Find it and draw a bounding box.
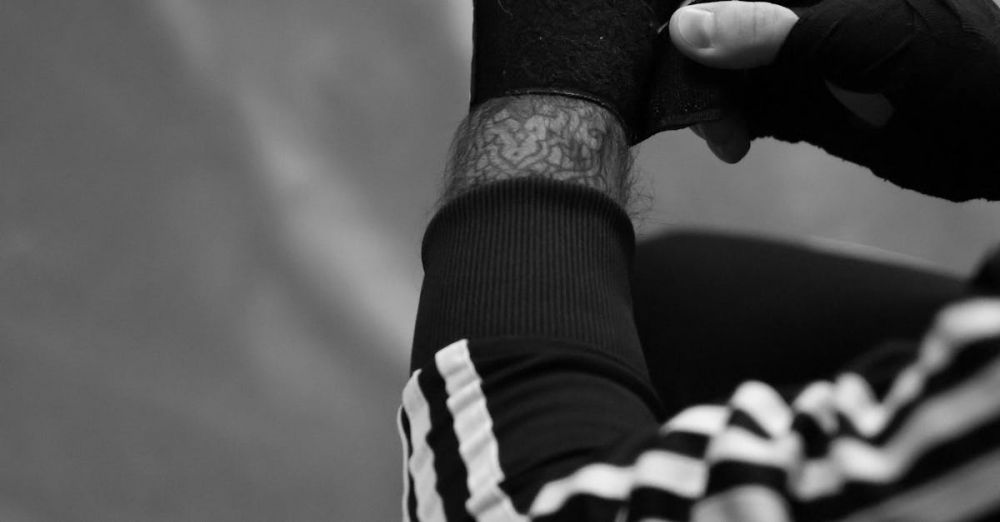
[472,0,658,142]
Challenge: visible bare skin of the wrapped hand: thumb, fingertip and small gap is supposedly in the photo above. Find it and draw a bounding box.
[668,0,892,163]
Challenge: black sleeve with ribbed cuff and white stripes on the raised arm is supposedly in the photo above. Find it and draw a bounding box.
[400,178,660,520]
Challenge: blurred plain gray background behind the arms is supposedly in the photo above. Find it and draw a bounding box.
[0,0,1000,522]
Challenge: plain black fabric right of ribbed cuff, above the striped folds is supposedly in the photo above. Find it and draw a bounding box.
[633,231,966,414]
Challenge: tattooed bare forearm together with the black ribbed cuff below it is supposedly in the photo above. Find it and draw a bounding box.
[412,92,645,373]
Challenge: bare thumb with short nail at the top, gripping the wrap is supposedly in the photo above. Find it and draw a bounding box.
[669,1,799,69]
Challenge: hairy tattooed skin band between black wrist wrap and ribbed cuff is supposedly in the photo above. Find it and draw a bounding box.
[445,96,631,206]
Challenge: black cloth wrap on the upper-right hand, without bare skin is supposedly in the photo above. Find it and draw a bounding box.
[741,0,1000,201]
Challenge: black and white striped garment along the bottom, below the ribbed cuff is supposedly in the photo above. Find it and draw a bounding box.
[399,297,1000,522]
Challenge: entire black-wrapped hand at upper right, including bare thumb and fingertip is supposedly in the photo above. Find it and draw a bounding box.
[669,0,1000,201]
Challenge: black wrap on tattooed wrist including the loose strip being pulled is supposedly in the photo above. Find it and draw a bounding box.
[472,0,728,144]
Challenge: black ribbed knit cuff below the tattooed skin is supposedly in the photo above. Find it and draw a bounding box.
[411,179,647,375]
